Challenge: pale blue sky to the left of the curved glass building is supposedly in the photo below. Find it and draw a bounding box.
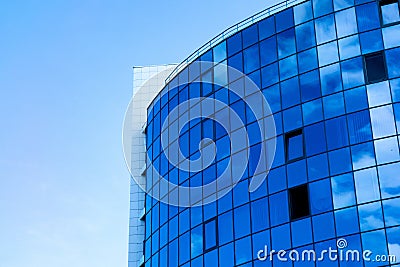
[0,0,278,267]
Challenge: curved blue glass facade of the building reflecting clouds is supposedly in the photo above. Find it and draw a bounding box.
[144,0,400,267]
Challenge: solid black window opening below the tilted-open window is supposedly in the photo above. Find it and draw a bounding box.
[289,184,310,220]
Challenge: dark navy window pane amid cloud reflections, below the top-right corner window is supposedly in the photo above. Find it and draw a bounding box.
[364,52,387,83]
